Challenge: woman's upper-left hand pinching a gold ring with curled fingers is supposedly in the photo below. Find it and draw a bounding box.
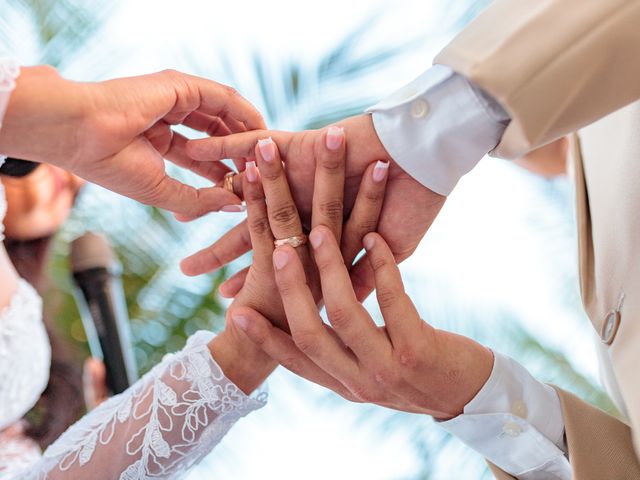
[0,67,264,215]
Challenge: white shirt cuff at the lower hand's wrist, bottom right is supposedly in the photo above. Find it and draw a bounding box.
[439,353,571,480]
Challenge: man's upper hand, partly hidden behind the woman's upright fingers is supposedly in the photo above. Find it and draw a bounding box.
[186,115,445,300]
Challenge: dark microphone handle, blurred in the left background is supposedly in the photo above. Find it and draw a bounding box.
[74,268,138,394]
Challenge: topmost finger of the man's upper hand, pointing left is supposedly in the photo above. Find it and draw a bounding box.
[187,130,294,161]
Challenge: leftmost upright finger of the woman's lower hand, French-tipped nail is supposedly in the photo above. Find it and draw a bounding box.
[242,162,274,275]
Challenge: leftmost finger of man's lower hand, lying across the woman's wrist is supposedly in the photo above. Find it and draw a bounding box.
[231,307,353,399]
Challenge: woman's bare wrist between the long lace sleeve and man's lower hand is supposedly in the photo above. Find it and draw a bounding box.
[209,322,278,395]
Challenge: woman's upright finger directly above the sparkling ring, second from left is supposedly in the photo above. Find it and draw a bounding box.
[255,138,304,242]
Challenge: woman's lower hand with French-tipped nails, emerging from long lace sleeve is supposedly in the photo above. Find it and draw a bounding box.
[205,127,388,393]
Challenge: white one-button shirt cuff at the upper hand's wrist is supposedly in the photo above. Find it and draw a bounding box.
[367,65,509,195]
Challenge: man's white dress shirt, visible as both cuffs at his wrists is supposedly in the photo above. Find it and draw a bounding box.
[368,65,571,480]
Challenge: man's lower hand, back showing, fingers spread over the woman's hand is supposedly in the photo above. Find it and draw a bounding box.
[232,227,493,419]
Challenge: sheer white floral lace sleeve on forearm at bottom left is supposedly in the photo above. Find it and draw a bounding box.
[19,332,266,480]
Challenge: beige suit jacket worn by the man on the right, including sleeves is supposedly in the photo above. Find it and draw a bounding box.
[436,0,640,480]
